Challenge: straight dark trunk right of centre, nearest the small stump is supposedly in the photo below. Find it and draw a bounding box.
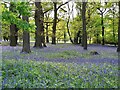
[82,2,87,50]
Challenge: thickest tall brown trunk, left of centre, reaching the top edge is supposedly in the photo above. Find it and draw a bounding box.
[34,2,42,48]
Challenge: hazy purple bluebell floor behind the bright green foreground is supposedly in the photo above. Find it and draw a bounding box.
[0,44,118,64]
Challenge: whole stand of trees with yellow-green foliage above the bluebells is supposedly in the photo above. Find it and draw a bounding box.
[2,0,120,53]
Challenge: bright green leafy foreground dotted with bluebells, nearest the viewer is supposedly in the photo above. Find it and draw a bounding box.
[2,60,118,88]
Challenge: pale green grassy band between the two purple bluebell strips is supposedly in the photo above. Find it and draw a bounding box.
[2,49,118,59]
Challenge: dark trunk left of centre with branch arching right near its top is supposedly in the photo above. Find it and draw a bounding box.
[52,2,57,44]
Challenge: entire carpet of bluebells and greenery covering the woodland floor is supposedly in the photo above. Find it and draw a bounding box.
[0,44,120,88]
